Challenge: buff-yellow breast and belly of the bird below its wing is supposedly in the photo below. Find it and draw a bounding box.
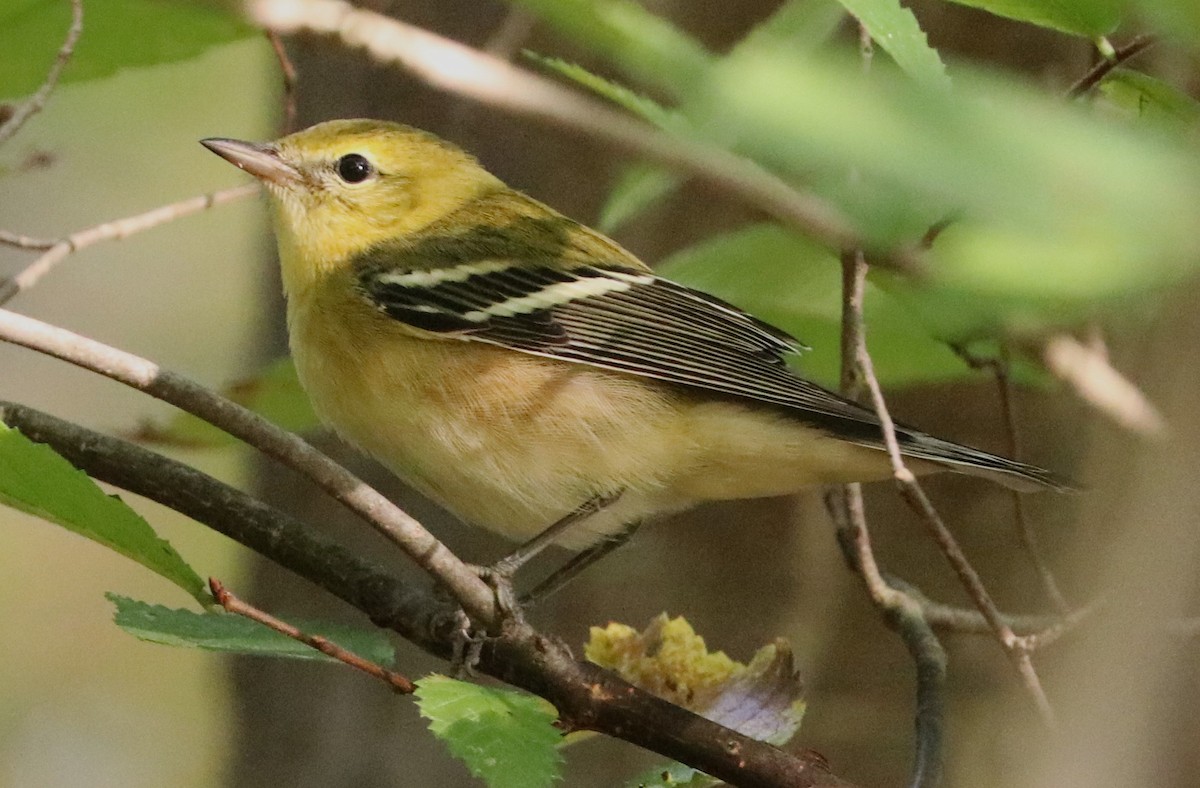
[289,287,887,549]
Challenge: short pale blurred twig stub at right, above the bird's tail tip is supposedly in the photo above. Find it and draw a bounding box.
[1038,333,1166,438]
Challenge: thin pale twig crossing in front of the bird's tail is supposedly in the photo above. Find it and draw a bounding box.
[858,343,1056,728]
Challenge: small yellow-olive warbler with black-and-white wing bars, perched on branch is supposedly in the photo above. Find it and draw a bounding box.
[203,120,1067,561]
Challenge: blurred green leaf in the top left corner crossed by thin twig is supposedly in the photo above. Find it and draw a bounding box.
[0,0,256,97]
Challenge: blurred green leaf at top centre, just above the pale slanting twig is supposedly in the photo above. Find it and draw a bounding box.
[515,0,710,92]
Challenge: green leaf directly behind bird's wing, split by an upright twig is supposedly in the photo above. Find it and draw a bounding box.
[656,224,982,386]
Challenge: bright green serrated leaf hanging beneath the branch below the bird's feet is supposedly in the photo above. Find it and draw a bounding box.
[416,675,563,788]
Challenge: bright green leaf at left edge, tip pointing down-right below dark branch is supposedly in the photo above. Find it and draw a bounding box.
[0,423,210,603]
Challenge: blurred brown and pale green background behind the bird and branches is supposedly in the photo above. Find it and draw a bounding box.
[0,0,1200,787]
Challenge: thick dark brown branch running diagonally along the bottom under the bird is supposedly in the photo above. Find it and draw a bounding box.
[0,402,847,788]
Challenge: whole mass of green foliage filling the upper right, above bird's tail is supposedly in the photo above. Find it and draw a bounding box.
[526,0,1200,383]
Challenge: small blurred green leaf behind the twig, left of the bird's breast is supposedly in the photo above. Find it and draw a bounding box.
[137,356,320,449]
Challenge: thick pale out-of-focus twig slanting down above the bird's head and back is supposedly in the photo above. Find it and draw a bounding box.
[247,0,922,272]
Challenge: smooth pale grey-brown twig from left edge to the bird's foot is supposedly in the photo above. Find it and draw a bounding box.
[0,309,499,626]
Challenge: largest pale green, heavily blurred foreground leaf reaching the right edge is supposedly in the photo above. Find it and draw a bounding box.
[691,50,1200,295]
